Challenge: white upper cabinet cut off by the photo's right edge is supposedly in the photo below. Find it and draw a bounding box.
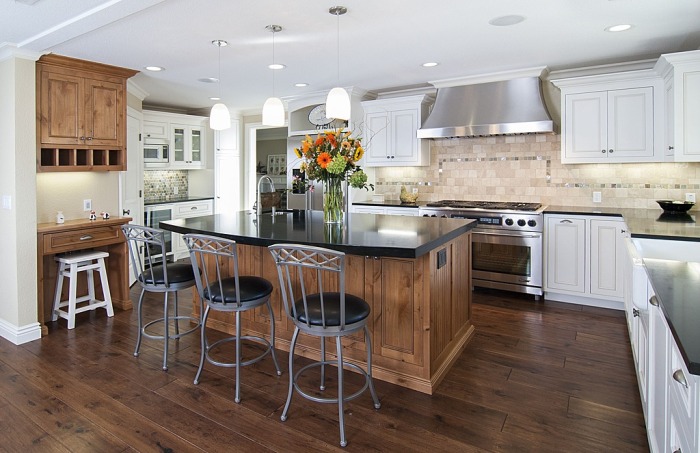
[655,50,700,162]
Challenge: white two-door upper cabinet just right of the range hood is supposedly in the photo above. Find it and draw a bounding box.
[553,70,664,164]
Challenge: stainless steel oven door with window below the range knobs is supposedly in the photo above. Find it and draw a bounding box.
[472,229,542,296]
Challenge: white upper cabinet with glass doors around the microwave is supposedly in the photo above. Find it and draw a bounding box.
[143,110,211,170]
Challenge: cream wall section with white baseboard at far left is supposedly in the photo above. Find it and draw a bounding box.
[0,56,41,343]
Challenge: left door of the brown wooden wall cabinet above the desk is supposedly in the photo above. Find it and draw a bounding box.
[41,71,83,144]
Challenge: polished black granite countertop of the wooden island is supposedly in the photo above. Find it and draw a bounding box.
[160,210,476,258]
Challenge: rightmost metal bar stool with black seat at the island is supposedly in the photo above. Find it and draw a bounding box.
[268,244,381,447]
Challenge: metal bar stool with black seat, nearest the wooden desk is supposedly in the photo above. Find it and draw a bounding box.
[122,225,200,371]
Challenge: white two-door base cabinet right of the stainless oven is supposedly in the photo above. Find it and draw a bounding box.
[545,214,625,308]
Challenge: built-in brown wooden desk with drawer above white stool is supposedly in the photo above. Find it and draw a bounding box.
[37,217,132,335]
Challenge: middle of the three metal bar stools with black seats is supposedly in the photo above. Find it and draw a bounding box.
[183,234,282,403]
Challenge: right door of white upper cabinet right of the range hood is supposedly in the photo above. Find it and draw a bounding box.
[608,87,654,157]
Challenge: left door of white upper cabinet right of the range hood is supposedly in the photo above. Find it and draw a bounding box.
[565,91,608,159]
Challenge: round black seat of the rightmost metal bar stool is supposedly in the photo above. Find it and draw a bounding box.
[295,293,369,326]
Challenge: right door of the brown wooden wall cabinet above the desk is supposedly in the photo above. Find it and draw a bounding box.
[85,79,124,146]
